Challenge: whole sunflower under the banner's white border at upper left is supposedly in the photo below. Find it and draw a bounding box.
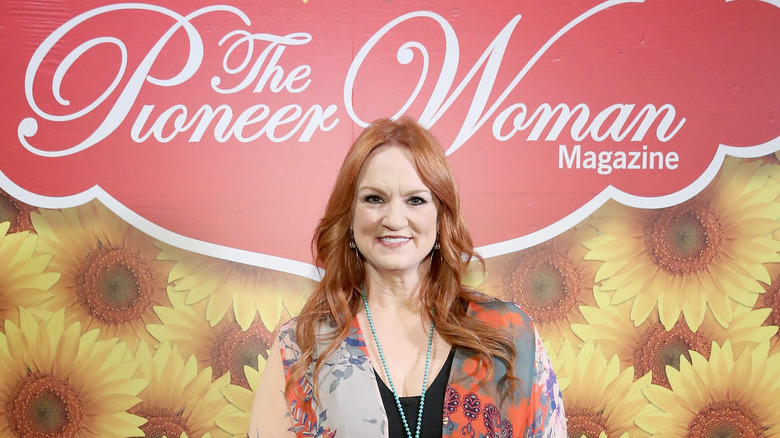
[32,201,171,348]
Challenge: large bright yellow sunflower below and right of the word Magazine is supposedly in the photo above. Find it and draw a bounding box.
[585,158,780,332]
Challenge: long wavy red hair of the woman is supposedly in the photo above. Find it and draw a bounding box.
[286,118,517,394]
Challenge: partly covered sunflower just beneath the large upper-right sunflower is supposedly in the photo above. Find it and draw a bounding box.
[572,287,777,387]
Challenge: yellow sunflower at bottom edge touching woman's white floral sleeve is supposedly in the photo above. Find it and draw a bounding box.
[550,340,650,438]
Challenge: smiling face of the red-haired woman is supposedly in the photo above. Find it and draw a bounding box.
[352,145,438,275]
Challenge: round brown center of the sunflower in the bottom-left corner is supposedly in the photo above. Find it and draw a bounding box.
[5,373,84,438]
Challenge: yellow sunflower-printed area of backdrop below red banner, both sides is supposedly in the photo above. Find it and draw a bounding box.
[0,155,780,437]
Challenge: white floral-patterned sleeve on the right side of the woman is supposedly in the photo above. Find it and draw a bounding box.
[533,328,567,438]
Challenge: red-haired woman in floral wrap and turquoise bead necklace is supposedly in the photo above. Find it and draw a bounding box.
[249,119,566,438]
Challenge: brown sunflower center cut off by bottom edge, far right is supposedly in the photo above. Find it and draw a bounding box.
[688,400,766,438]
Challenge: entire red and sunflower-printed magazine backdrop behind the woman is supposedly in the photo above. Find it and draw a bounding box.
[0,0,780,437]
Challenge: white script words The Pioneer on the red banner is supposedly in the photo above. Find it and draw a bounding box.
[17,4,338,157]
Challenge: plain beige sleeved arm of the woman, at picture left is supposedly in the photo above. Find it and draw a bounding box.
[248,339,296,438]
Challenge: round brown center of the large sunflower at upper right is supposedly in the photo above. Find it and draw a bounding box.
[645,201,723,274]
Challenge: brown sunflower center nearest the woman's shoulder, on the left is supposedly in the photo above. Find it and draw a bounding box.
[211,321,273,389]
